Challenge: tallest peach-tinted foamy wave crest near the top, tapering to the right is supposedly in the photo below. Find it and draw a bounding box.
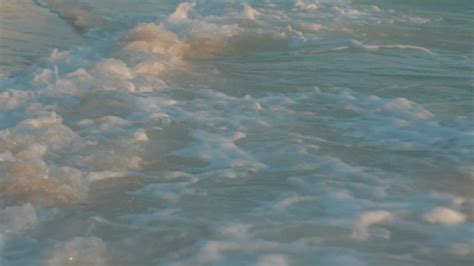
[122,6,285,62]
